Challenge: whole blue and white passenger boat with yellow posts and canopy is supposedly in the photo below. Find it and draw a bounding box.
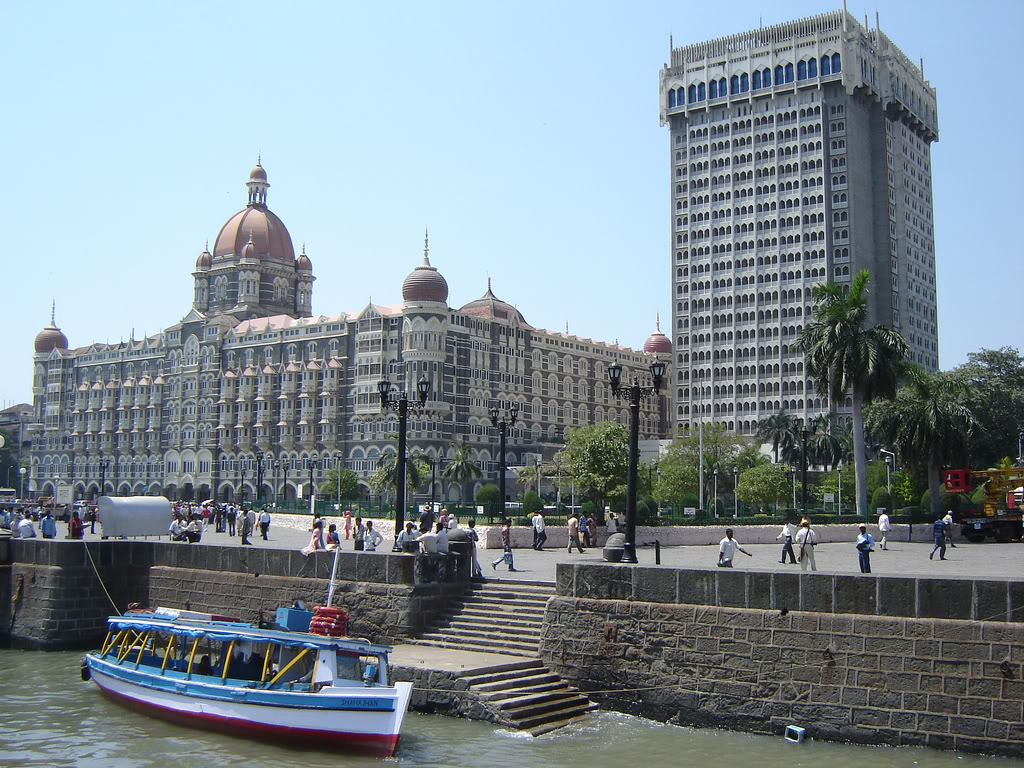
[82,608,413,757]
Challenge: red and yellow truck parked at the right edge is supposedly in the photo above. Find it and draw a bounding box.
[942,467,1024,544]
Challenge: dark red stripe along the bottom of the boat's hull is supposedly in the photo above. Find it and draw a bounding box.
[98,685,398,758]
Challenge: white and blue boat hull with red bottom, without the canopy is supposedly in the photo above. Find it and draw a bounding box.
[86,654,412,757]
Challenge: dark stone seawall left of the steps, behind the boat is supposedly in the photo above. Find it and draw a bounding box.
[0,540,468,649]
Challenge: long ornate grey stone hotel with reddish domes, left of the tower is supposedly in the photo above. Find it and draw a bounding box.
[29,163,672,501]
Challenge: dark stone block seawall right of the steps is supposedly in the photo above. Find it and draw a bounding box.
[541,564,1024,757]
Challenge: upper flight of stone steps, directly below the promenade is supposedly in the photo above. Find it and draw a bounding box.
[411,580,555,658]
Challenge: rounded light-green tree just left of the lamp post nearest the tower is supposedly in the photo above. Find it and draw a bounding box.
[564,421,629,506]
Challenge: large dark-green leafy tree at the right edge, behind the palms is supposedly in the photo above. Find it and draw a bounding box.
[952,347,1024,469]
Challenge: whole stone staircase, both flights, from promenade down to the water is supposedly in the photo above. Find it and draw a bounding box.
[411,580,598,736]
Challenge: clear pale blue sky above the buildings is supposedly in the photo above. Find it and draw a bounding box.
[0,0,1024,403]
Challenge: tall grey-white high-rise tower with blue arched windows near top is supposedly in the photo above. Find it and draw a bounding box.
[660,10,938,434]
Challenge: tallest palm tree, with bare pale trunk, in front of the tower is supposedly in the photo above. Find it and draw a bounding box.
[795,269,907,515]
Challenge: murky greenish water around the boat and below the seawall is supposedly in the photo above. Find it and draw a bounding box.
[0,650,1024,768]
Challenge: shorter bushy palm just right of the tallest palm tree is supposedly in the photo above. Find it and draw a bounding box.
[866,366,977,515]
